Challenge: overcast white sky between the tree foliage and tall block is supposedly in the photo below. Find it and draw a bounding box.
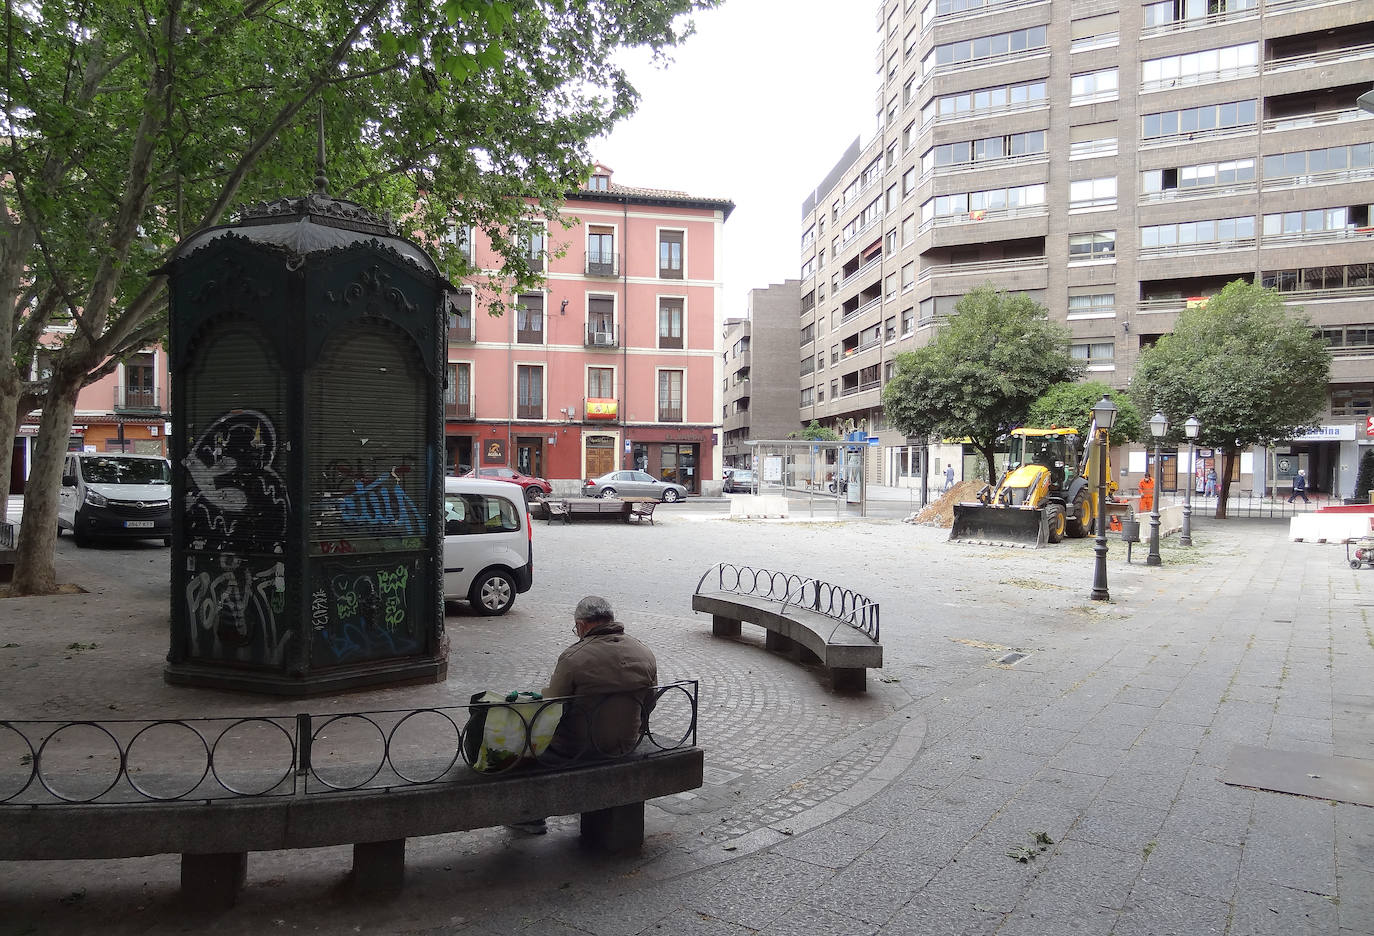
[592,0,878,317]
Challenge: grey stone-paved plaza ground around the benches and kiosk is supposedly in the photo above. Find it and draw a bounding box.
[0,506,1374,936]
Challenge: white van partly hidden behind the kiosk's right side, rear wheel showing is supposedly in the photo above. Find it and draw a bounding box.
[444,478,534,614]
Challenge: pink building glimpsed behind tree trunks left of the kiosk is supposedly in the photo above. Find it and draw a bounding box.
[10,339,172,493]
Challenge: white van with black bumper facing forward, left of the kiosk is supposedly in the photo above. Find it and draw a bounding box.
[58,452,172,546]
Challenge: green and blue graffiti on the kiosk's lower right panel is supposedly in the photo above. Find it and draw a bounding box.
[311,564,420,664]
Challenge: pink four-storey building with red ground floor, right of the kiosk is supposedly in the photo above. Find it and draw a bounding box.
[444,166,734,493]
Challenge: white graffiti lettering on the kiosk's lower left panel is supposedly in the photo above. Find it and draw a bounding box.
[185,554,294,665]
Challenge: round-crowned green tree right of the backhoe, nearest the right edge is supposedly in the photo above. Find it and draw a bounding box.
[1131,279,1331,518]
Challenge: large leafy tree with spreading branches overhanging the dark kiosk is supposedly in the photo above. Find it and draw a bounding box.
[0,0,719,594]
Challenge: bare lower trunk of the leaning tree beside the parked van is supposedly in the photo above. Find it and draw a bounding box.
[10,384,81,597]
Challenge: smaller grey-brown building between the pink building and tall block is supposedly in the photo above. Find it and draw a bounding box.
[720,279,807,467]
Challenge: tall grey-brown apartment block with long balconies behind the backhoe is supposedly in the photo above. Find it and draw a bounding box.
[802,0,1374,495]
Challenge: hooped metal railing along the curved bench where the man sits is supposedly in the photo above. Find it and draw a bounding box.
[0,680,698,807]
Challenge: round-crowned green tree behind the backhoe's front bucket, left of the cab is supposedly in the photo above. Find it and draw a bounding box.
[882,285,1081,478]
